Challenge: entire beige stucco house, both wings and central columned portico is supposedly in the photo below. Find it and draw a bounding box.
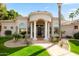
[0,11,79,40]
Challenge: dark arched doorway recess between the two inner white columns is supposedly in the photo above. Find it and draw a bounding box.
[36,19,45,38]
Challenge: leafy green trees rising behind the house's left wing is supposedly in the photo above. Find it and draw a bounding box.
[0,3,19,20]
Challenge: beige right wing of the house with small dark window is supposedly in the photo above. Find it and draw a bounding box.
[62,19,79,36]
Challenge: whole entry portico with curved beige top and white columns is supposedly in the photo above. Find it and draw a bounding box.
[29,11,52,40]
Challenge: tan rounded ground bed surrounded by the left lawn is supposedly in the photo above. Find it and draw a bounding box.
[4,39,27,48]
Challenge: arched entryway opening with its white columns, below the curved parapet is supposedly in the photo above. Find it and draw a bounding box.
[30,19,50,40]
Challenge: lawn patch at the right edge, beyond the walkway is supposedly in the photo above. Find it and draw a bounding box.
[69,40,79,54]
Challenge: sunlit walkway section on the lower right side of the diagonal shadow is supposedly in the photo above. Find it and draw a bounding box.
[47,45,77,56]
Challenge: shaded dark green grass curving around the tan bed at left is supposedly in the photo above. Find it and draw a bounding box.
[0,36,23,56]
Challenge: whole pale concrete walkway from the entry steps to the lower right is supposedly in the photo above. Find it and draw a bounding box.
[34,43,78,56]
